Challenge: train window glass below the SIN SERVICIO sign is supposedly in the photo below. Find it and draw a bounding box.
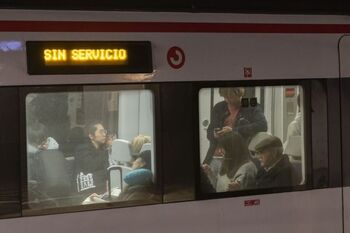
[24,86,158,213]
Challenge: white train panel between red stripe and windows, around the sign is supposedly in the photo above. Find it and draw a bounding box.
[0,32,341,86]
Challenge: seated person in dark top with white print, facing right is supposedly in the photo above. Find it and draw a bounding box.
[75,121,111,203]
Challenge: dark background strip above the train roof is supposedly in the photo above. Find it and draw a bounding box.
[0,0,350,15]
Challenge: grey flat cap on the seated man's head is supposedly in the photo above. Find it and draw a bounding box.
[249,132,283,151]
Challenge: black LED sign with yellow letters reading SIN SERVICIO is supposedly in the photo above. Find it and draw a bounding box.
[26,41,153,74]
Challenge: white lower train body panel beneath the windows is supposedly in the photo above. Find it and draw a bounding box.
[0,188,342,233]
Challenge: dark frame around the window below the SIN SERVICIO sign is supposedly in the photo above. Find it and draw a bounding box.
[19,83,163,216]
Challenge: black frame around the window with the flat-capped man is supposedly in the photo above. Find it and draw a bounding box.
[193,79,314,200]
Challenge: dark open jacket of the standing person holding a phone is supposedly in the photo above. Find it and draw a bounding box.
[204,101,267,164]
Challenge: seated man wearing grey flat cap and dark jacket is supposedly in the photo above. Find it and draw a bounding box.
[249,132,296,188]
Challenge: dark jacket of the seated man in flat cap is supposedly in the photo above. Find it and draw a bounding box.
[256,155,296,188]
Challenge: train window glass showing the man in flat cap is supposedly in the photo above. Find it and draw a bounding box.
[199,86,306,193]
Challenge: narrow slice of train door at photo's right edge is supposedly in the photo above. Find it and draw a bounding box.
[339,36,350,233]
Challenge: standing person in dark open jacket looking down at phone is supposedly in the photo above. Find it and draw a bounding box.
[203,87,267,165]
